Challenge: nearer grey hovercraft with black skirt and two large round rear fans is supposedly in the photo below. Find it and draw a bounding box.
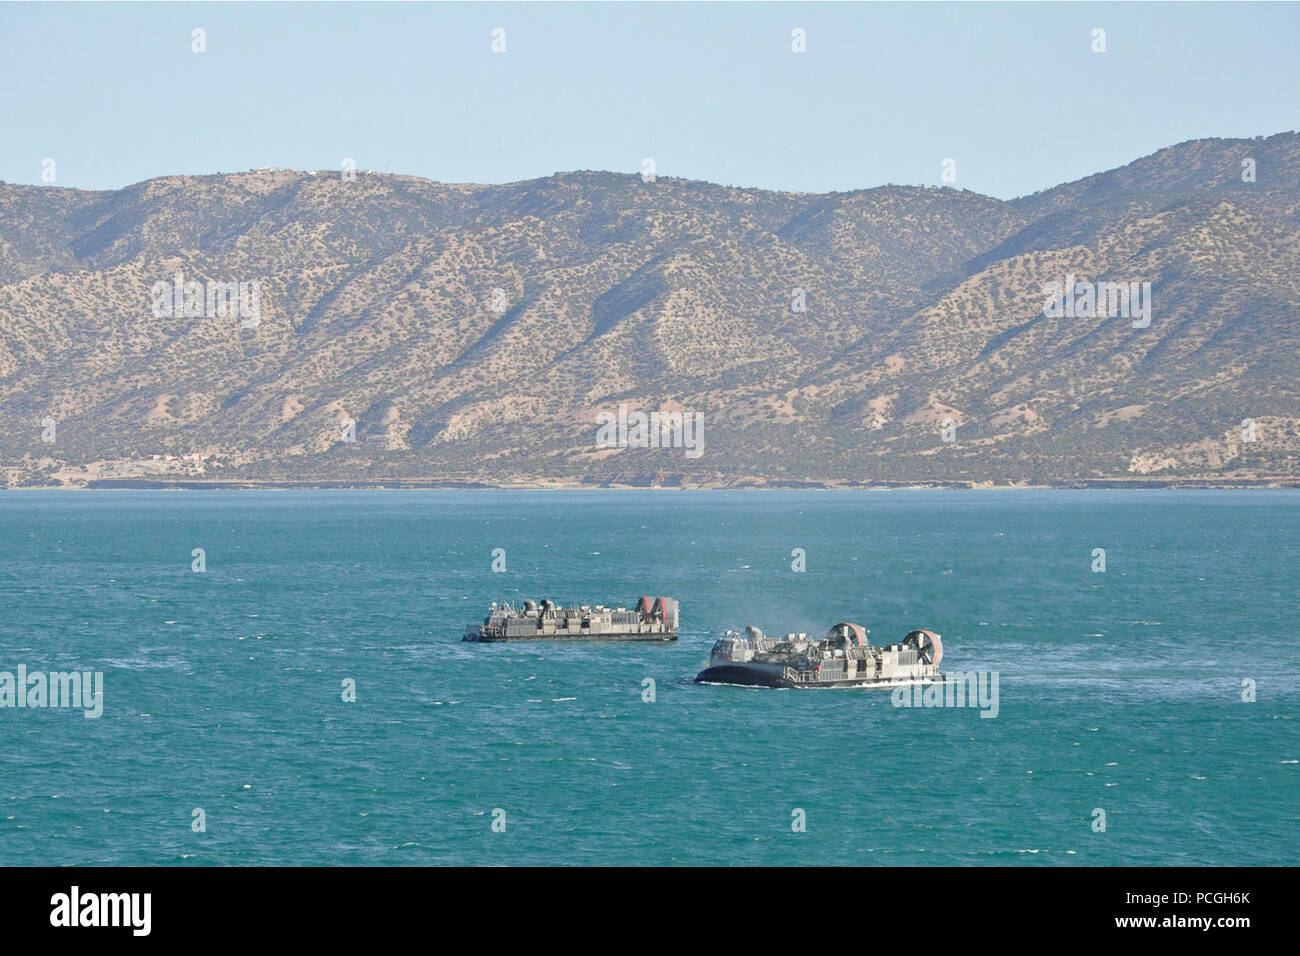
[696,622,944,688]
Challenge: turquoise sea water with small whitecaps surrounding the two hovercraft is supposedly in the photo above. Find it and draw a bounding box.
[0,490,1300,865]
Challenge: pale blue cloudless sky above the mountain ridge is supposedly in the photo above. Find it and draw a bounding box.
[0,3,1300,198]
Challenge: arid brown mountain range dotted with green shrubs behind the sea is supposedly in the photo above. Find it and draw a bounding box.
[0,133,1300,486]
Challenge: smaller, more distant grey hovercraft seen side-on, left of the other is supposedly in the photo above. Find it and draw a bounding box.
[462,597,677,641]
